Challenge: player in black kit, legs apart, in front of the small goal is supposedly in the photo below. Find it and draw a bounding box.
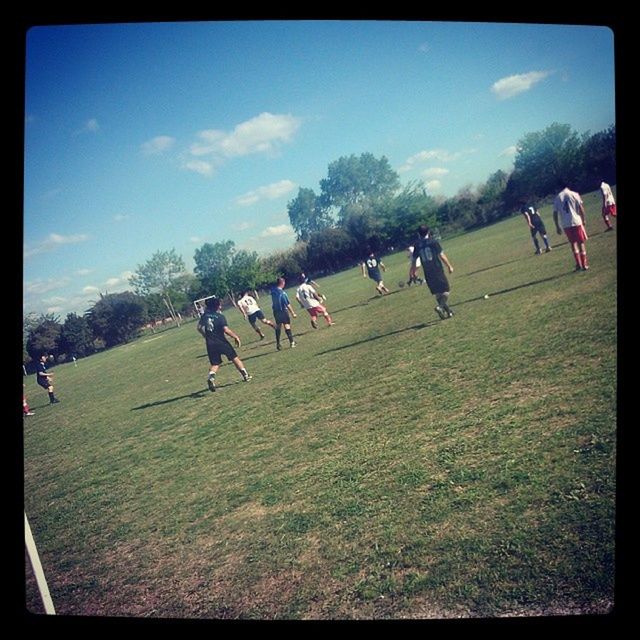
[196,298,252,391]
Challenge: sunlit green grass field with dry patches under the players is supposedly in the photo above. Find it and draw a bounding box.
[24,194,617,620]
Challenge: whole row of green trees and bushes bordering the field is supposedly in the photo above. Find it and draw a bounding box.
[23,123,616,364]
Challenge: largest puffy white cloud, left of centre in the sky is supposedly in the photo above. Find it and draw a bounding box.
[185,112,301,173]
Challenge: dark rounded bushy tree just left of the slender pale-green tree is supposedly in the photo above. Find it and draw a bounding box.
[86,291,148,347]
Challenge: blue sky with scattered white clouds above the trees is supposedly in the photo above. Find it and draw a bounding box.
[23,21,615,320]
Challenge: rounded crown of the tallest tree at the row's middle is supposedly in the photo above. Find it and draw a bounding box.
[320,153,400,210]
